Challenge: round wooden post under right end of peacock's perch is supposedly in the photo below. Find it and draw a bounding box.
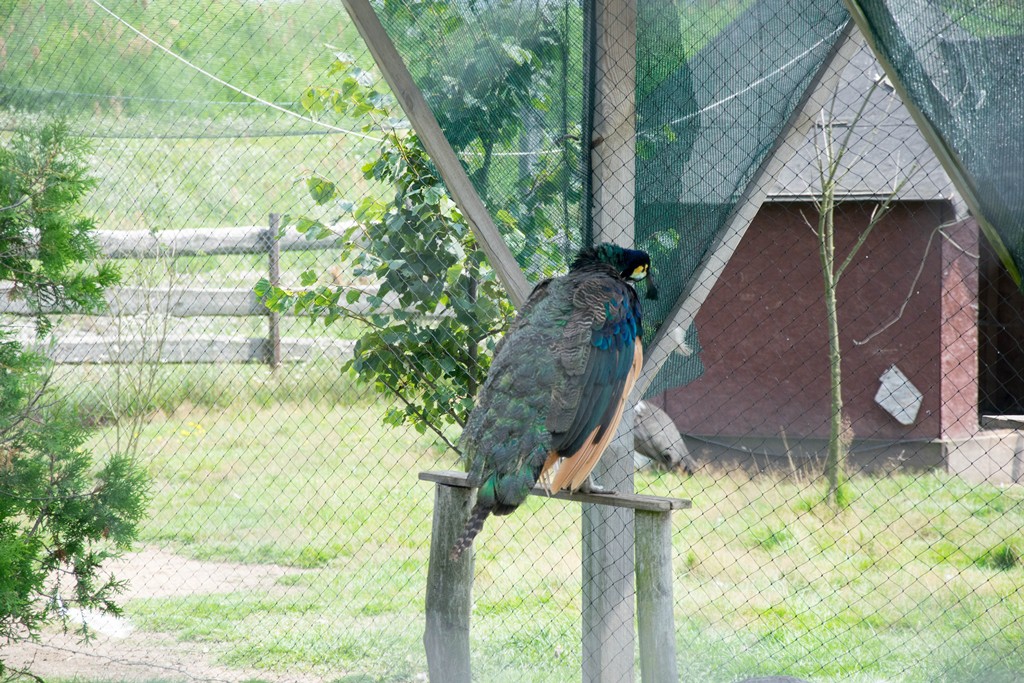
[636,510,679,683]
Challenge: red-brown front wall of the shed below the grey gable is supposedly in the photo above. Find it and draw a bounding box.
[662,202,958,440]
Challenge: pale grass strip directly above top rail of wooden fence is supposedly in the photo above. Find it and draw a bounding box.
[85,132,376,235]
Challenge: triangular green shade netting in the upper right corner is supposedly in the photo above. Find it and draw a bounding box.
[858,0,1024,285]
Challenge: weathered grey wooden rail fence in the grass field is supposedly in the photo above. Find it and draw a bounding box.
[0,214,372,367]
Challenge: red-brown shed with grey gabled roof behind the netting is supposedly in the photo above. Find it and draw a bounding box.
[654,34,1024,480]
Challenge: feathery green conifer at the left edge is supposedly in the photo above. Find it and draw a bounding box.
[0,122,147,677]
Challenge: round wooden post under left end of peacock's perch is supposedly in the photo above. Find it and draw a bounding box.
[423,483,473,683]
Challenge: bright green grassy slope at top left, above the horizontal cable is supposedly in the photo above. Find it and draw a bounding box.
[0,0,373,116]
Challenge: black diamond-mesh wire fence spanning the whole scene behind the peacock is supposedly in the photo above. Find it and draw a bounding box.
[0,0,1024,682]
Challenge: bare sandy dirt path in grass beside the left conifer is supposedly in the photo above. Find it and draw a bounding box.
[0,549,321,683]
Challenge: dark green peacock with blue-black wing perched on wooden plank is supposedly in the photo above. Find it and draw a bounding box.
[452,244,657,558]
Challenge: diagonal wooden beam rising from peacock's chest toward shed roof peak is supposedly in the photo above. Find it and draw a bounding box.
[633,22,860,397]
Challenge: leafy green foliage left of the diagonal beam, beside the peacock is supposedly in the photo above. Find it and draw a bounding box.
[256,55,514,438]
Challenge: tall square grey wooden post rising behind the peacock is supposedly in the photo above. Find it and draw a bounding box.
[583,0,637,683]
